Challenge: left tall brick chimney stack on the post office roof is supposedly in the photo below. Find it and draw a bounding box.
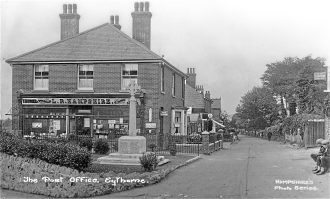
[60,4,80,40]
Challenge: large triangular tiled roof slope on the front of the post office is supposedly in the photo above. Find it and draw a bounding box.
[7,23,161,63]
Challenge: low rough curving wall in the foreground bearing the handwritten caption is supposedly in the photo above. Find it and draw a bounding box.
[0,153,180,198]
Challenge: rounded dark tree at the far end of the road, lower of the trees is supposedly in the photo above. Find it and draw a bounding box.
[236,87,278,130]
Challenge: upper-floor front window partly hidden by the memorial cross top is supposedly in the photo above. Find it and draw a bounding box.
[121,64,138,90]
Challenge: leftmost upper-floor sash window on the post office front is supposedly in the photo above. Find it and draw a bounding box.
[34,65,49,90]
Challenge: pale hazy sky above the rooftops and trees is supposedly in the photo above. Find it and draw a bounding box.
[0,0,330,118]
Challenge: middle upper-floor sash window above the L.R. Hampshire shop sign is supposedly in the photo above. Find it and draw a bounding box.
[78,65,94,90]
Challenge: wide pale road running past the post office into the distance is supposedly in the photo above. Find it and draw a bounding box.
[1,135,330,198]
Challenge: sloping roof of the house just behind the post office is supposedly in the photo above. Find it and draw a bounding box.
[185,84,204,108]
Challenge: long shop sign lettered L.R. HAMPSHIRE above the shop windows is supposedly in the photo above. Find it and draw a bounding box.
[22,98,140,105]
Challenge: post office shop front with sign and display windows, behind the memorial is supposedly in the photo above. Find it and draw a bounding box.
[21,93,143,138]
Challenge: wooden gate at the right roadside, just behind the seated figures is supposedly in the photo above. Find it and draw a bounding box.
[304,119,325,147]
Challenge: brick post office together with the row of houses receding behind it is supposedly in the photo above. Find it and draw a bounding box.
[6,2,221,147]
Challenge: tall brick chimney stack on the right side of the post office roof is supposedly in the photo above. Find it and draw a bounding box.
[132,2,152,49]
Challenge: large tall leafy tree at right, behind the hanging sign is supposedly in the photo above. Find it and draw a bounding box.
[261,56,325,115]
